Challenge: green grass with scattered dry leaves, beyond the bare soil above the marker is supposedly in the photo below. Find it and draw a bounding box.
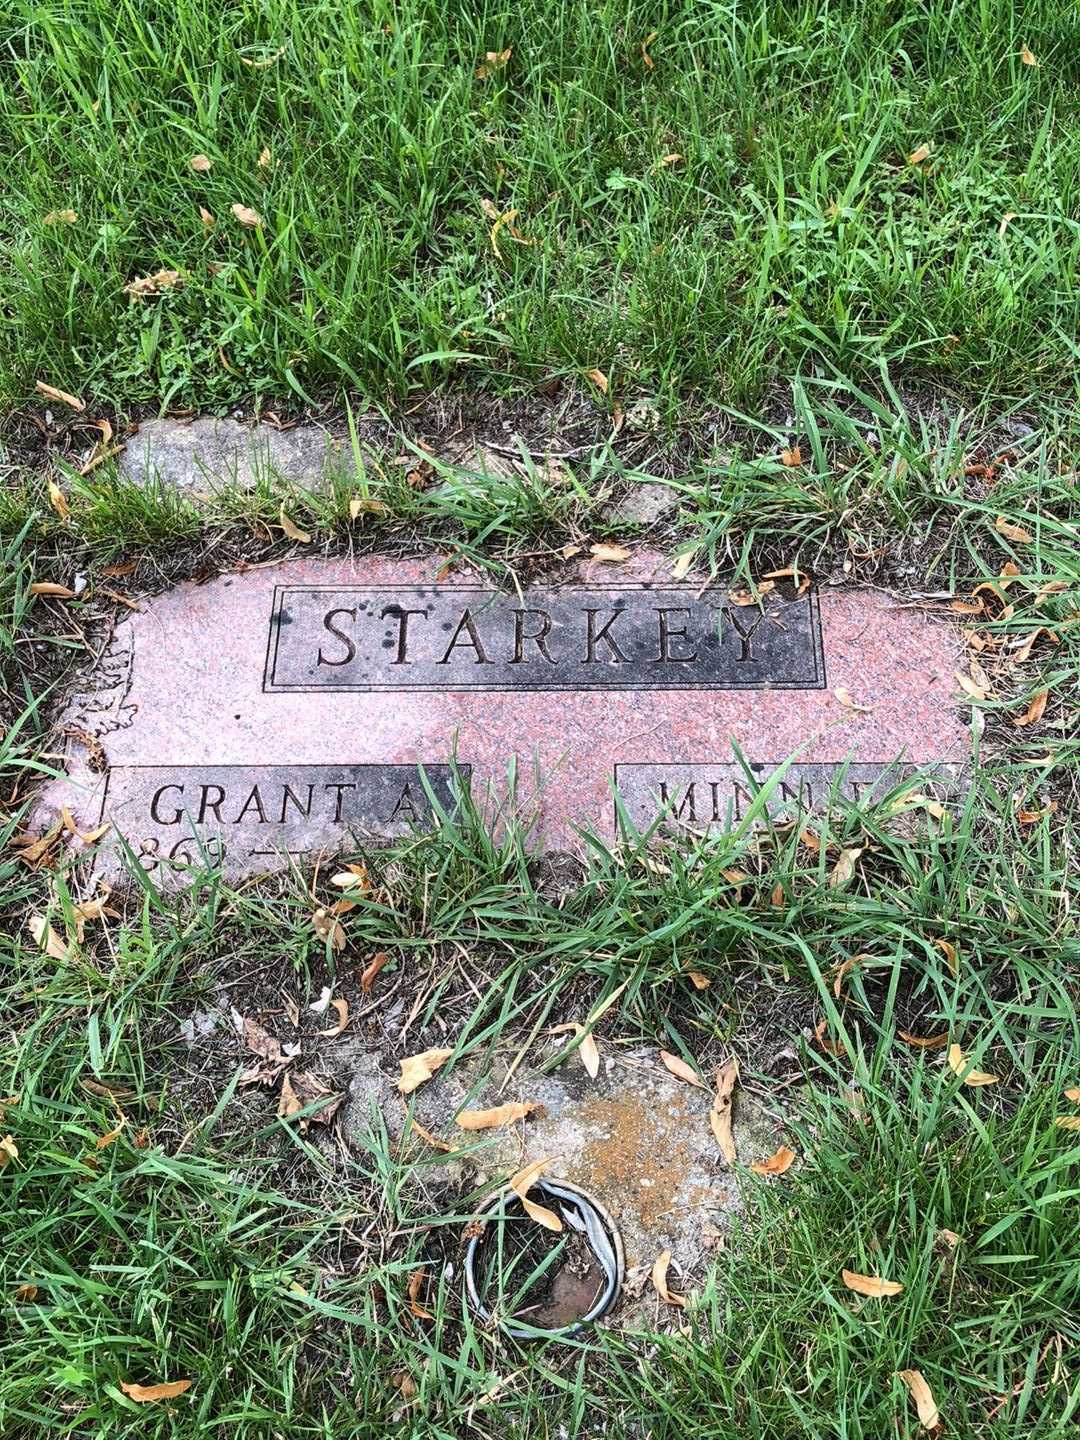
[0,0,1080,418]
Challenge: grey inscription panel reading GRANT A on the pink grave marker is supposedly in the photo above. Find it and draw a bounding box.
[101,765,469,871]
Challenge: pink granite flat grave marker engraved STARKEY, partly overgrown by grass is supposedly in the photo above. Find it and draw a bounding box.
[37,553,966,880]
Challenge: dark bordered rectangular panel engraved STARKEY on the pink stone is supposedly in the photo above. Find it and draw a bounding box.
[262,583,825,694]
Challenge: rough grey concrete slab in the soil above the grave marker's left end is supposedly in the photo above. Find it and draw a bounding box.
[120,415,341,495]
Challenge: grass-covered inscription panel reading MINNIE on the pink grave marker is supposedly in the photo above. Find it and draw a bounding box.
[613,757,956,831]
